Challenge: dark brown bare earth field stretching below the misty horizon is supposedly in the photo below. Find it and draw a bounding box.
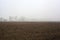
[0,22,60,40]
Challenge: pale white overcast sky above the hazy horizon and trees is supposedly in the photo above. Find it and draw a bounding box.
[0,0,60,21]
